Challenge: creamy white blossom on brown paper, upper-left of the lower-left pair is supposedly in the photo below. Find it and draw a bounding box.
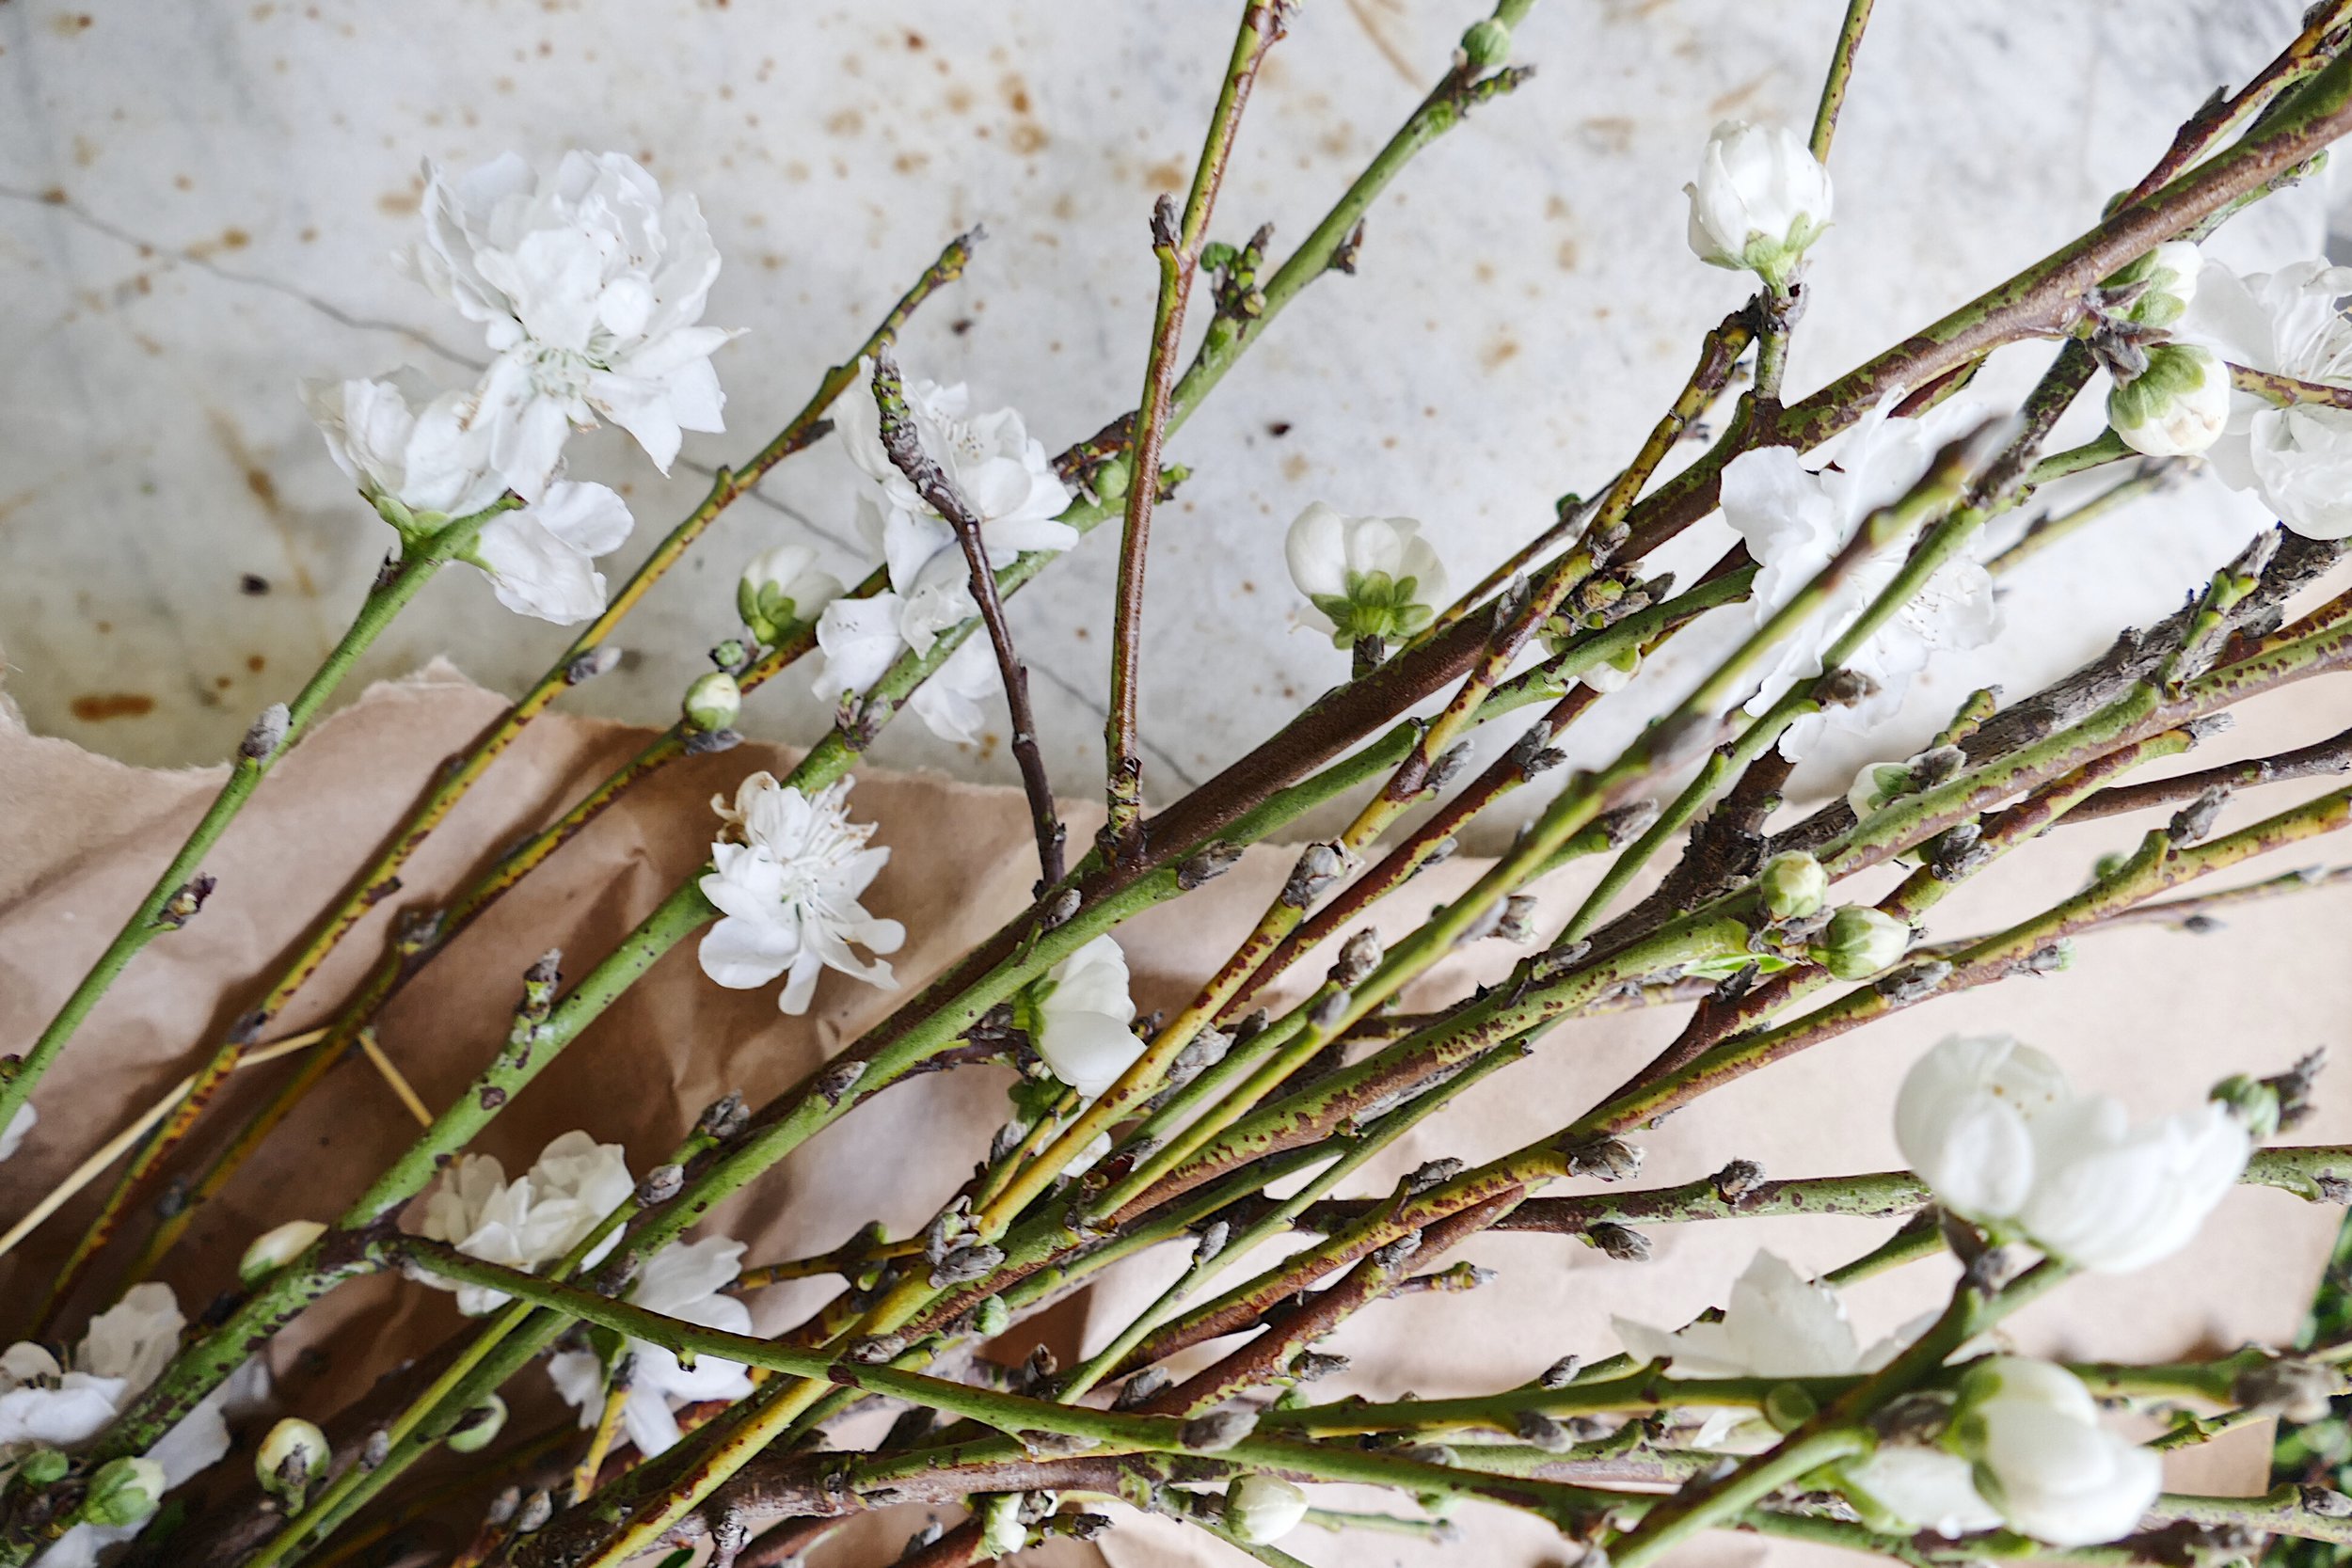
[419,1131,638,1317]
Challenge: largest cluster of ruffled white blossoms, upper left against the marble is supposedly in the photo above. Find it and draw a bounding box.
[304,152,737,626]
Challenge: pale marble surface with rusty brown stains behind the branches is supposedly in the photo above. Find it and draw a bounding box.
[0,0,2327,832]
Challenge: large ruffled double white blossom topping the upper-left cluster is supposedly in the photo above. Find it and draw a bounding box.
[395,152,737,500]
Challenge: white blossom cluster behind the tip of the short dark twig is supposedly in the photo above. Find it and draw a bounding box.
[803,359,1077,745]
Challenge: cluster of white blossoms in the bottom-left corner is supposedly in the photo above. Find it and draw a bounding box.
[0,1284,268,1568]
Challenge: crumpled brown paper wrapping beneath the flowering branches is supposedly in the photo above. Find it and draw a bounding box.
[0,663,2352,1568]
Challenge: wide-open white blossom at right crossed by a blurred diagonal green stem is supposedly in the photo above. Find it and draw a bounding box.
[1722,392,2002,757]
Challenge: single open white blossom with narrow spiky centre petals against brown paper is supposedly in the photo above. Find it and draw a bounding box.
[701,775,906,1013]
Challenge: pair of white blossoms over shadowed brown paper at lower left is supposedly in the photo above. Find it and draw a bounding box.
[419,1131,751,1458]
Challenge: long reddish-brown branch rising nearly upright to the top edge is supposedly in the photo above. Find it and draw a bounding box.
[1101,0,1289,860]
